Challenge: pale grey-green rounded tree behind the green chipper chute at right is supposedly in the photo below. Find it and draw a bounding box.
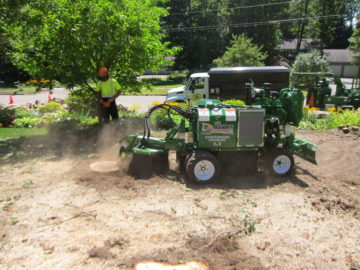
[290,50,330,86]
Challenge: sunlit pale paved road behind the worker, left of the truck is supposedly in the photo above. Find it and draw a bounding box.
[0,88,165,112]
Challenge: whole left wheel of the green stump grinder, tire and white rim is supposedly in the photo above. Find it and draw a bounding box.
[186,150,220,184]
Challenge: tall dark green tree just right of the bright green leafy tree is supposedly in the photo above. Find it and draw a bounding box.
[164,0,229,71]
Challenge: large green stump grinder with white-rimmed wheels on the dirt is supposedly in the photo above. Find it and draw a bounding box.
[120,85,316,184]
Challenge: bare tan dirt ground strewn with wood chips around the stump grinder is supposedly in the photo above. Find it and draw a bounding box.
[0,131,360,270]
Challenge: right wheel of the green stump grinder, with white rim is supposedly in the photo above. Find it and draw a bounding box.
[264,148,295,177]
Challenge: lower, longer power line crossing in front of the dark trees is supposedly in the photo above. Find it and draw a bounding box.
[164,14,342,32]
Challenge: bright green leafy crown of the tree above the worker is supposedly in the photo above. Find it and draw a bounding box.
[5,0,177,90]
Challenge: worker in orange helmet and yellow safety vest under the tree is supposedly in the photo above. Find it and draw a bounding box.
[95,67,121,122]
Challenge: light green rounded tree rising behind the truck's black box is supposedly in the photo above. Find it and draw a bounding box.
[214,35,267,67]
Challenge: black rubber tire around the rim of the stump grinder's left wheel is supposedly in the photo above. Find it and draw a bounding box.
[186,150,221,185]
